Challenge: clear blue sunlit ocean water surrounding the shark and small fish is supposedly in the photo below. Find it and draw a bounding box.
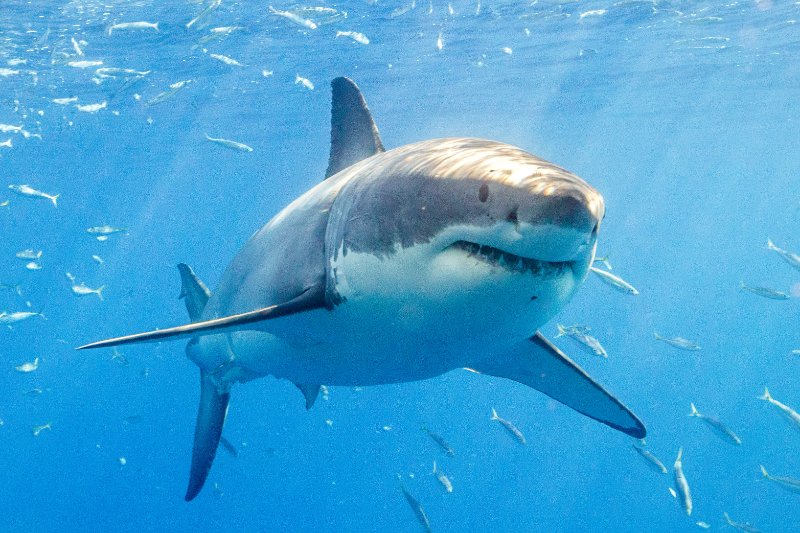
[0,0,800,532]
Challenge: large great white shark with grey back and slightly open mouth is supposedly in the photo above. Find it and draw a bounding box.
[81,78,646,501]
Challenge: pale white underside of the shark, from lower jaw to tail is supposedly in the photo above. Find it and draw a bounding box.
[198,241,579,385]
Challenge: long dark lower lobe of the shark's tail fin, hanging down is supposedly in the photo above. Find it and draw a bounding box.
[186,369,231,502]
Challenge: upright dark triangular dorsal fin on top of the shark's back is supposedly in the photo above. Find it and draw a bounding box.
[325,78,384,178]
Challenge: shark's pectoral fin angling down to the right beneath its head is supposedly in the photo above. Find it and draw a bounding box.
[469,333,647,439]
